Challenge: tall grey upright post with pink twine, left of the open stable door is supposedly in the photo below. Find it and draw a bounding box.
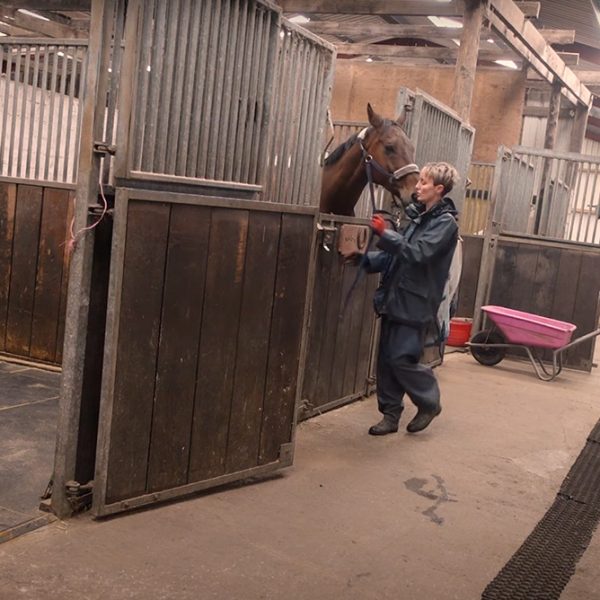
[51,0,116,518]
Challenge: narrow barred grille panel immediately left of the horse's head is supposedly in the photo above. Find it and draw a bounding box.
[264,19,334,206]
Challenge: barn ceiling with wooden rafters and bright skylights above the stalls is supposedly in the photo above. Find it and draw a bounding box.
[0,0,600,96]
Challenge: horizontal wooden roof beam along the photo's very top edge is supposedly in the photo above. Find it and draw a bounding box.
[279,0,540,17]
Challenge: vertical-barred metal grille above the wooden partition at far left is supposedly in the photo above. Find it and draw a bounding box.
[0,38,87,183]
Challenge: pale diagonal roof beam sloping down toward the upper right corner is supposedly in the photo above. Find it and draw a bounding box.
[487,0,592,106]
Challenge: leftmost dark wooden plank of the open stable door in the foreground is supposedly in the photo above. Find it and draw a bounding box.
[106,201,170,501]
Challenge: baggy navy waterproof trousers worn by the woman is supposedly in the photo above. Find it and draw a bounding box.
[377,316,440,420]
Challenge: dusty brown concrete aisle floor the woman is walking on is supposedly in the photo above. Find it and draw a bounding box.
[0,353,600,600]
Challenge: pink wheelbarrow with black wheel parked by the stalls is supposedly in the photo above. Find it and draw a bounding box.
[466,305,600,381]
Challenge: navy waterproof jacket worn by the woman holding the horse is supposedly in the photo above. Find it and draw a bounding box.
[364,198,458,327]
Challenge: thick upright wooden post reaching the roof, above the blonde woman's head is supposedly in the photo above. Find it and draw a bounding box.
[452,0,485,122]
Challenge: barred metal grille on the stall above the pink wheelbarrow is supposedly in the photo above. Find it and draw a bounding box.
[494,147,600,244]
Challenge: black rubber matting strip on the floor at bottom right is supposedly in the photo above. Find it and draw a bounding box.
[481,421,600,600]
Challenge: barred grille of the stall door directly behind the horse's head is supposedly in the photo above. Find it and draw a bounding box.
[396,87,475,212]
